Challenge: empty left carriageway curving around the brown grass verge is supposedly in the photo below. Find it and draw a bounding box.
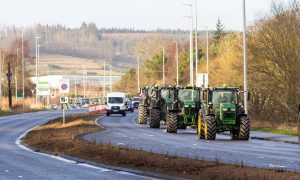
[0,110,155,180]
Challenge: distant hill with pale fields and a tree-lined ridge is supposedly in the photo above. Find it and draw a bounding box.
[1,23,210,73]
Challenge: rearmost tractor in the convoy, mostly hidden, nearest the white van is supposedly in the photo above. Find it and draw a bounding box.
[138,86,154,124]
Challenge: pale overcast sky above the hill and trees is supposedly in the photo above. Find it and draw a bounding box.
[0,0,289,30]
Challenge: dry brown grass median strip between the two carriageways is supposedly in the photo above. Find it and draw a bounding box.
[23,115,300,180]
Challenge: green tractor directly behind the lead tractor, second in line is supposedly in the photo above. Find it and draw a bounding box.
[166,87,201,133]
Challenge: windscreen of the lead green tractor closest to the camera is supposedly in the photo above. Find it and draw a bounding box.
[212,90,237,104]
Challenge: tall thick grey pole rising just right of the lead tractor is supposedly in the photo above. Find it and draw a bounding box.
[242,0,248,114]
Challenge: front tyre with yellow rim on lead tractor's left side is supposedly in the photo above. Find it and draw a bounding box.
[204,116,217,140]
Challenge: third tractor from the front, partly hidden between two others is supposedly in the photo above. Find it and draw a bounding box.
[149,86,175,128]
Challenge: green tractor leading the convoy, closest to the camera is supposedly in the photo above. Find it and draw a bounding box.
[198,86,250,140]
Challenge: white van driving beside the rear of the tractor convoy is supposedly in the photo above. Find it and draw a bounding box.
[106,92,126,116]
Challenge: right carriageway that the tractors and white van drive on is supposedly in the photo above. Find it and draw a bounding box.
[83,112,300,172]
